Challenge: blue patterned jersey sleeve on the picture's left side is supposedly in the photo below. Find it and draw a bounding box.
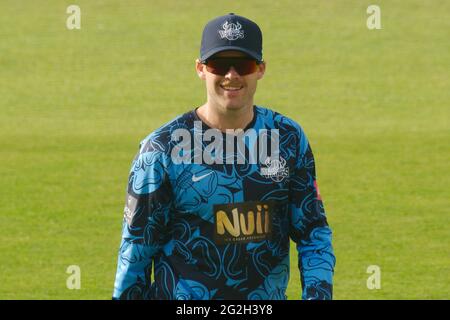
[113,151,172,300]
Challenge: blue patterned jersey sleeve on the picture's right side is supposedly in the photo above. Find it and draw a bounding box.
[290,133,336,300]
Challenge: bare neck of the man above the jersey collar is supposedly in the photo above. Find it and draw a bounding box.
[197,102,253,132]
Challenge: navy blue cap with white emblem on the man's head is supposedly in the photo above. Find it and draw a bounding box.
[200,13,262,62]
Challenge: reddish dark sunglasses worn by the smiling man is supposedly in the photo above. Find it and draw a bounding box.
[206,58,257,76]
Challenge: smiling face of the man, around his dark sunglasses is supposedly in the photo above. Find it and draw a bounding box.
[196,51,265,112]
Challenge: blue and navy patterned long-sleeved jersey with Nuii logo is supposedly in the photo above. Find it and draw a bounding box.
[113,106,335,300]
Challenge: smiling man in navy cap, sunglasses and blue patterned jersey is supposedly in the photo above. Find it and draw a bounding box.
[113,13,335,299]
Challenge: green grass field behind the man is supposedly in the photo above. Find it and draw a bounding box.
[0,0,450,299]
